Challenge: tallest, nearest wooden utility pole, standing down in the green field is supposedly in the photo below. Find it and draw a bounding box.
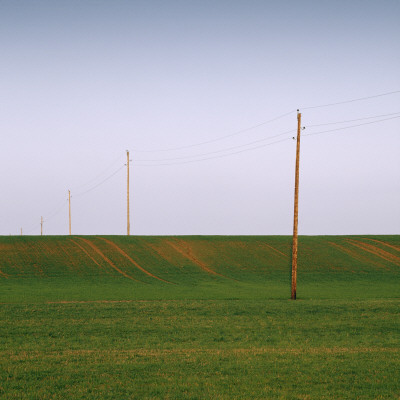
[291,110,301,300]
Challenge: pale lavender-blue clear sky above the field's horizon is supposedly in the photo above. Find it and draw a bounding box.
[0,0,400,235]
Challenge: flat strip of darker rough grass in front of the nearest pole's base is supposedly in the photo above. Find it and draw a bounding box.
[0,300,400,399]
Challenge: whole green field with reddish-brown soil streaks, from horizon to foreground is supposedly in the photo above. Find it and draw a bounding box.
[0,236,400,399]
